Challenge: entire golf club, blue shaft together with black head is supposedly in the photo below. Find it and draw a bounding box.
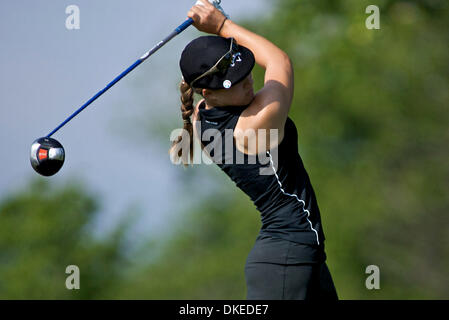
[30,0,228,176]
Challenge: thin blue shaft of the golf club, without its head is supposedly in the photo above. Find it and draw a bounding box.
[47,18,193,138]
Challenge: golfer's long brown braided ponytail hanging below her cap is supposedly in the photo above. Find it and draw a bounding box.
[169,79,194,166]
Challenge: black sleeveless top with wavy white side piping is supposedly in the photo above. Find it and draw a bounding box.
[195,102,325,247]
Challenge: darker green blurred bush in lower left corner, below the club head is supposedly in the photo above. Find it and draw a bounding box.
[0,179,130,299]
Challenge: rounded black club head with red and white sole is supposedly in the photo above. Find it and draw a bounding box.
[30,137,65,177]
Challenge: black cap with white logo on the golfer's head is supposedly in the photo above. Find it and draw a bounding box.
[179,36,255,89]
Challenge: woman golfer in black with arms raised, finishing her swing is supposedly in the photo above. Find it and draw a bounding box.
[171,0,338,299]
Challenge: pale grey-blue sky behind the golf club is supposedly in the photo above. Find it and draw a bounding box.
[0,0,270,242]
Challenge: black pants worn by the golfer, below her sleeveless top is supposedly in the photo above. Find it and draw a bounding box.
[245,237,338,300]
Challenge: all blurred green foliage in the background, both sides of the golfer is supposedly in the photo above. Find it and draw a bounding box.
[0,0,449,299]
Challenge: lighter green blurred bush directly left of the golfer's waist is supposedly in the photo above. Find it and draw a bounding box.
[117,186,260,299]
